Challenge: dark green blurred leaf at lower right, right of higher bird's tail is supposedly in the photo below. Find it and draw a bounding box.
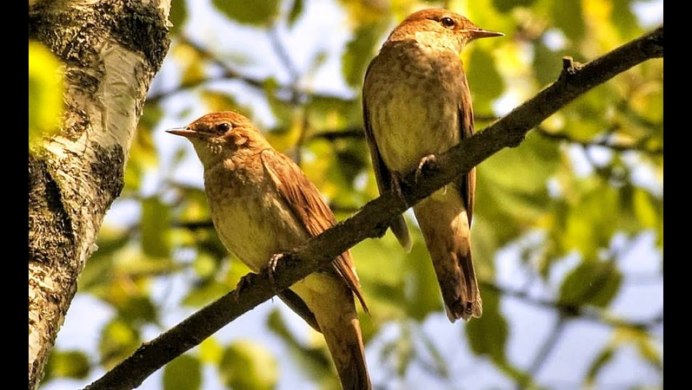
[558,261,622,307]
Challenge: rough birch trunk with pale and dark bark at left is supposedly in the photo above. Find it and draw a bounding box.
[29,0,170,389]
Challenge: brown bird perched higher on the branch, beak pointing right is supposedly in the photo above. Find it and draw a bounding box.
[363,9,503,322]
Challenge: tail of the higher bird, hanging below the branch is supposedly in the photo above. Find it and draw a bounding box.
[413,189,483,322]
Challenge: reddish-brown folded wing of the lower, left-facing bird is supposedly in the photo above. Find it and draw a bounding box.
[261,149,368,312]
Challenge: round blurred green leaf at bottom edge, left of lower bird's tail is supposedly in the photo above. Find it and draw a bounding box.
[219,341,279,390]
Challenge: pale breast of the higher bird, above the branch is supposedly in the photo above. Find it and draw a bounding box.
[364,42,461,172]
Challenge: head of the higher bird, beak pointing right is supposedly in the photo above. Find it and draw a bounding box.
[388,8,504,54]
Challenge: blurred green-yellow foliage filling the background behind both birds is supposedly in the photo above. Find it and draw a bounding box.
[40,0,663,389]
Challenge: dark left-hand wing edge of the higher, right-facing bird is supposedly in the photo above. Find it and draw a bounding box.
[362,61,411,252]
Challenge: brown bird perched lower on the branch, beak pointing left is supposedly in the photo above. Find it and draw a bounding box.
[168,112,371,390]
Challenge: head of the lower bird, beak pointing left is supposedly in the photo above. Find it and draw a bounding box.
[166,111,270,166]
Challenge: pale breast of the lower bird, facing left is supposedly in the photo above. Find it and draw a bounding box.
[205,155,306,271]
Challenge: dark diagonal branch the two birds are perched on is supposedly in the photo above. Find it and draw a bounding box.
[87,27,663,389]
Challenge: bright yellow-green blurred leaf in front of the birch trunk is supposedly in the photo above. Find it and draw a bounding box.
[29,40,64,148]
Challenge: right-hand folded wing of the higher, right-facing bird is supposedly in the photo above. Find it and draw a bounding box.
[458,68,476,226]
